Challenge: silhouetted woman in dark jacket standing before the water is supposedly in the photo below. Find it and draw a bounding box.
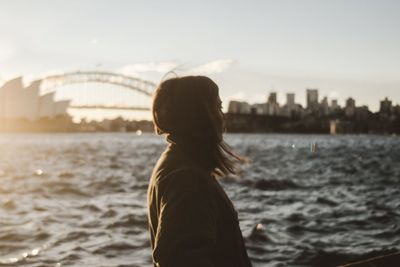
[148,76,251,267]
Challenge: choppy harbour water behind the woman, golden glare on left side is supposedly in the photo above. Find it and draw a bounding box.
[0,134,400,267]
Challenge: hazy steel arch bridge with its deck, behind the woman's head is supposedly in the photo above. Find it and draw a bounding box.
[40,71,156,110]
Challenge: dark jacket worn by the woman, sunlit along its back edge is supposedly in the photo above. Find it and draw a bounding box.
[148,144,251,267]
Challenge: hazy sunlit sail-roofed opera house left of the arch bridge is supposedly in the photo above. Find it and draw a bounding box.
[0,77,69,121]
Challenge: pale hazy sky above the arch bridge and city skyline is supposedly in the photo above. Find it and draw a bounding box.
[0,0,400,114]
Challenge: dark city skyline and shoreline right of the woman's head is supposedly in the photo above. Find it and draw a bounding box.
[226,89,400,134]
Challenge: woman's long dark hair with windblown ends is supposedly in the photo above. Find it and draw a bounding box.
[152,76,244,176]
